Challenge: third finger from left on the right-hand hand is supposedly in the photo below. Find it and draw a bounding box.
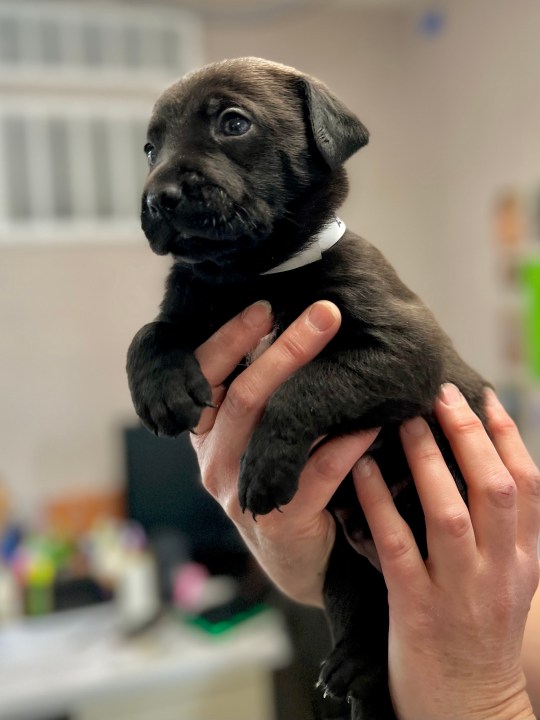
[434,384,517,560]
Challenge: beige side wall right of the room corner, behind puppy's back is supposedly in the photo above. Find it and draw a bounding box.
[400,0,540,381]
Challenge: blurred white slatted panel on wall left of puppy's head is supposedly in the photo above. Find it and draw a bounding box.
[0,0,201,244]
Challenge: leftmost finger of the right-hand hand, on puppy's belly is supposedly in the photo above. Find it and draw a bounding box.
[352,456,429,596]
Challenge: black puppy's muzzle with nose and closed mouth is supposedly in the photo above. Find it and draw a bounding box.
[141,185,268,264]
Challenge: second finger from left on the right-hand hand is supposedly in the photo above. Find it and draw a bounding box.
[400,417,476,573]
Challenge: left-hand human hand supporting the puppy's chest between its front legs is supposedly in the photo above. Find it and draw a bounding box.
[193,302,376,606]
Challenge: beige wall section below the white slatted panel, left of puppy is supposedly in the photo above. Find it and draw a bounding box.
[0,245,171,517]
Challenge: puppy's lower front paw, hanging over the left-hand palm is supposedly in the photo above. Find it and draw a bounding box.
[238,428,307,516]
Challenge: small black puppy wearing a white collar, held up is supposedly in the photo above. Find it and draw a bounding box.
[127,58,485,720]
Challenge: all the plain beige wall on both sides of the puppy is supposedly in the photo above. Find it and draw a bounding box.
[0,0,540,515]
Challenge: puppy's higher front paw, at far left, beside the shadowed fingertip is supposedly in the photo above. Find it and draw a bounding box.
[130,353,212,437]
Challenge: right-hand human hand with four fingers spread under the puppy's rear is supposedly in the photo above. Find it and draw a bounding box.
[353,385,540,720]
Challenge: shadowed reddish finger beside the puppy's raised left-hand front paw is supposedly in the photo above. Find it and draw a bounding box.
[195,300,272,434]
